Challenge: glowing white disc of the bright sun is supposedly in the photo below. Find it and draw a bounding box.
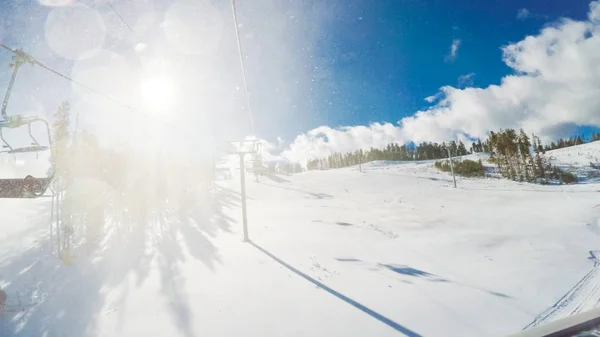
[140,77,175,113]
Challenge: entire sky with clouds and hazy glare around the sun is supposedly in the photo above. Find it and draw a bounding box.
[0,0,600,159]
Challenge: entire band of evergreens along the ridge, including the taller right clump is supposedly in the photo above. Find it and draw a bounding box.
[307,129,600,183]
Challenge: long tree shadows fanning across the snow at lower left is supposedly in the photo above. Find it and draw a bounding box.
[0,169,240,337]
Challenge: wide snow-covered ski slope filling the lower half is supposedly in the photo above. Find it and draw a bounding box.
[0,144,600,337]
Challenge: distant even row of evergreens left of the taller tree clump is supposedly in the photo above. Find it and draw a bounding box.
[307,141,469,170]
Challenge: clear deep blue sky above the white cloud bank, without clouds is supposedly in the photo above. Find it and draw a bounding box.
[282,0,589,133]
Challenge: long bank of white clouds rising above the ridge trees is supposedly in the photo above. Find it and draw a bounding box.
[283,1,600,160]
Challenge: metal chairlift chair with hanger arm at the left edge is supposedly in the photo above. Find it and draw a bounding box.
[0,50,55,198]
